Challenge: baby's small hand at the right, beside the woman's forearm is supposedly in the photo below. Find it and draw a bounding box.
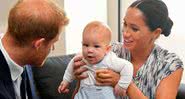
[114,84,126,96]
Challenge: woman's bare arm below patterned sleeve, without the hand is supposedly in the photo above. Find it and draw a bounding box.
[127,68,183,99]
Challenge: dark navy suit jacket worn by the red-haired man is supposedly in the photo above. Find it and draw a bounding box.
[0,50,39,99]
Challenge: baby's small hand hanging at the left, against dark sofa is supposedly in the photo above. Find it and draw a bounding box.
[58,81,69,93]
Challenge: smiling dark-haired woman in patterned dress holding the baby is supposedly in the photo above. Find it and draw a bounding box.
[74,0,183,99]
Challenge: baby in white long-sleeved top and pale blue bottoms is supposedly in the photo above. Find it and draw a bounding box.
[58,21,133,99]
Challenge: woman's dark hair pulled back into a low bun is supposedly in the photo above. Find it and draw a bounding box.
[130,0,173,36]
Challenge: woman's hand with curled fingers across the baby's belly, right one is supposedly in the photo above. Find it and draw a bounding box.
[96,69,120,87]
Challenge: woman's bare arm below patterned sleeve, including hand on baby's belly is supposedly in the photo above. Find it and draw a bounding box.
[96,68,183,99]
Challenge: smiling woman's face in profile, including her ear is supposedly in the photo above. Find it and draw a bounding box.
[123,8,156,52]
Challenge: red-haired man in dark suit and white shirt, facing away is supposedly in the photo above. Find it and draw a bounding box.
[0,0,68,99]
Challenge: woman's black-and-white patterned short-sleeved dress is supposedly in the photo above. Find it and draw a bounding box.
[112,43,183,99]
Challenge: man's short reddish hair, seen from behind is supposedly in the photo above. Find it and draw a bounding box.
[7,0,68,46]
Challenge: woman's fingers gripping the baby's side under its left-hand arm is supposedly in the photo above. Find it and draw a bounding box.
[73,54,87,80]
